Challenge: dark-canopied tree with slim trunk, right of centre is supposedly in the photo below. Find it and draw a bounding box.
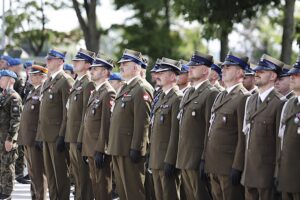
[175,0,279,60]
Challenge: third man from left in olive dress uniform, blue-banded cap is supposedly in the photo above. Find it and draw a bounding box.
[65,49,95,200]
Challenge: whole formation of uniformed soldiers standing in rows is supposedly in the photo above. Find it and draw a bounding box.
[0,49,300,200]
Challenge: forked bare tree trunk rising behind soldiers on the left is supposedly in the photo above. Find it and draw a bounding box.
[72,0,107,52]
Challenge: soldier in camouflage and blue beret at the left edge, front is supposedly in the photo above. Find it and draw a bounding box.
[0,70,22,199]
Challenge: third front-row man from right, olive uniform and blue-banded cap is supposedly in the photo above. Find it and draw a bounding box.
[200,53,249,200]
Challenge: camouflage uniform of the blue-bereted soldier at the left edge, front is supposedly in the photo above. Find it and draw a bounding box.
[0,90,22,195]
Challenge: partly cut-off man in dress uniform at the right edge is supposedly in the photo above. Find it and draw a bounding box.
[277,56,300,200]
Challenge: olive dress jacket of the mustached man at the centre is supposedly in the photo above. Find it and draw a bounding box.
[149,87,182,169]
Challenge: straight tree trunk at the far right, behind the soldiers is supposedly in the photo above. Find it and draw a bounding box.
[281,0,295,64]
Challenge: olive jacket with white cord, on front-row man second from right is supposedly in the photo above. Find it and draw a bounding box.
[243,90,284,188]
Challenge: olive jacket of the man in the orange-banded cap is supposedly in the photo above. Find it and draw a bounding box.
[18,86,42,146]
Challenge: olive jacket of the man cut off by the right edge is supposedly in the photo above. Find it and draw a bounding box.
[278,97,300,193]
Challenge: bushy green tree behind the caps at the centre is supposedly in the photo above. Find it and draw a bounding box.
[114,0,181,61]
